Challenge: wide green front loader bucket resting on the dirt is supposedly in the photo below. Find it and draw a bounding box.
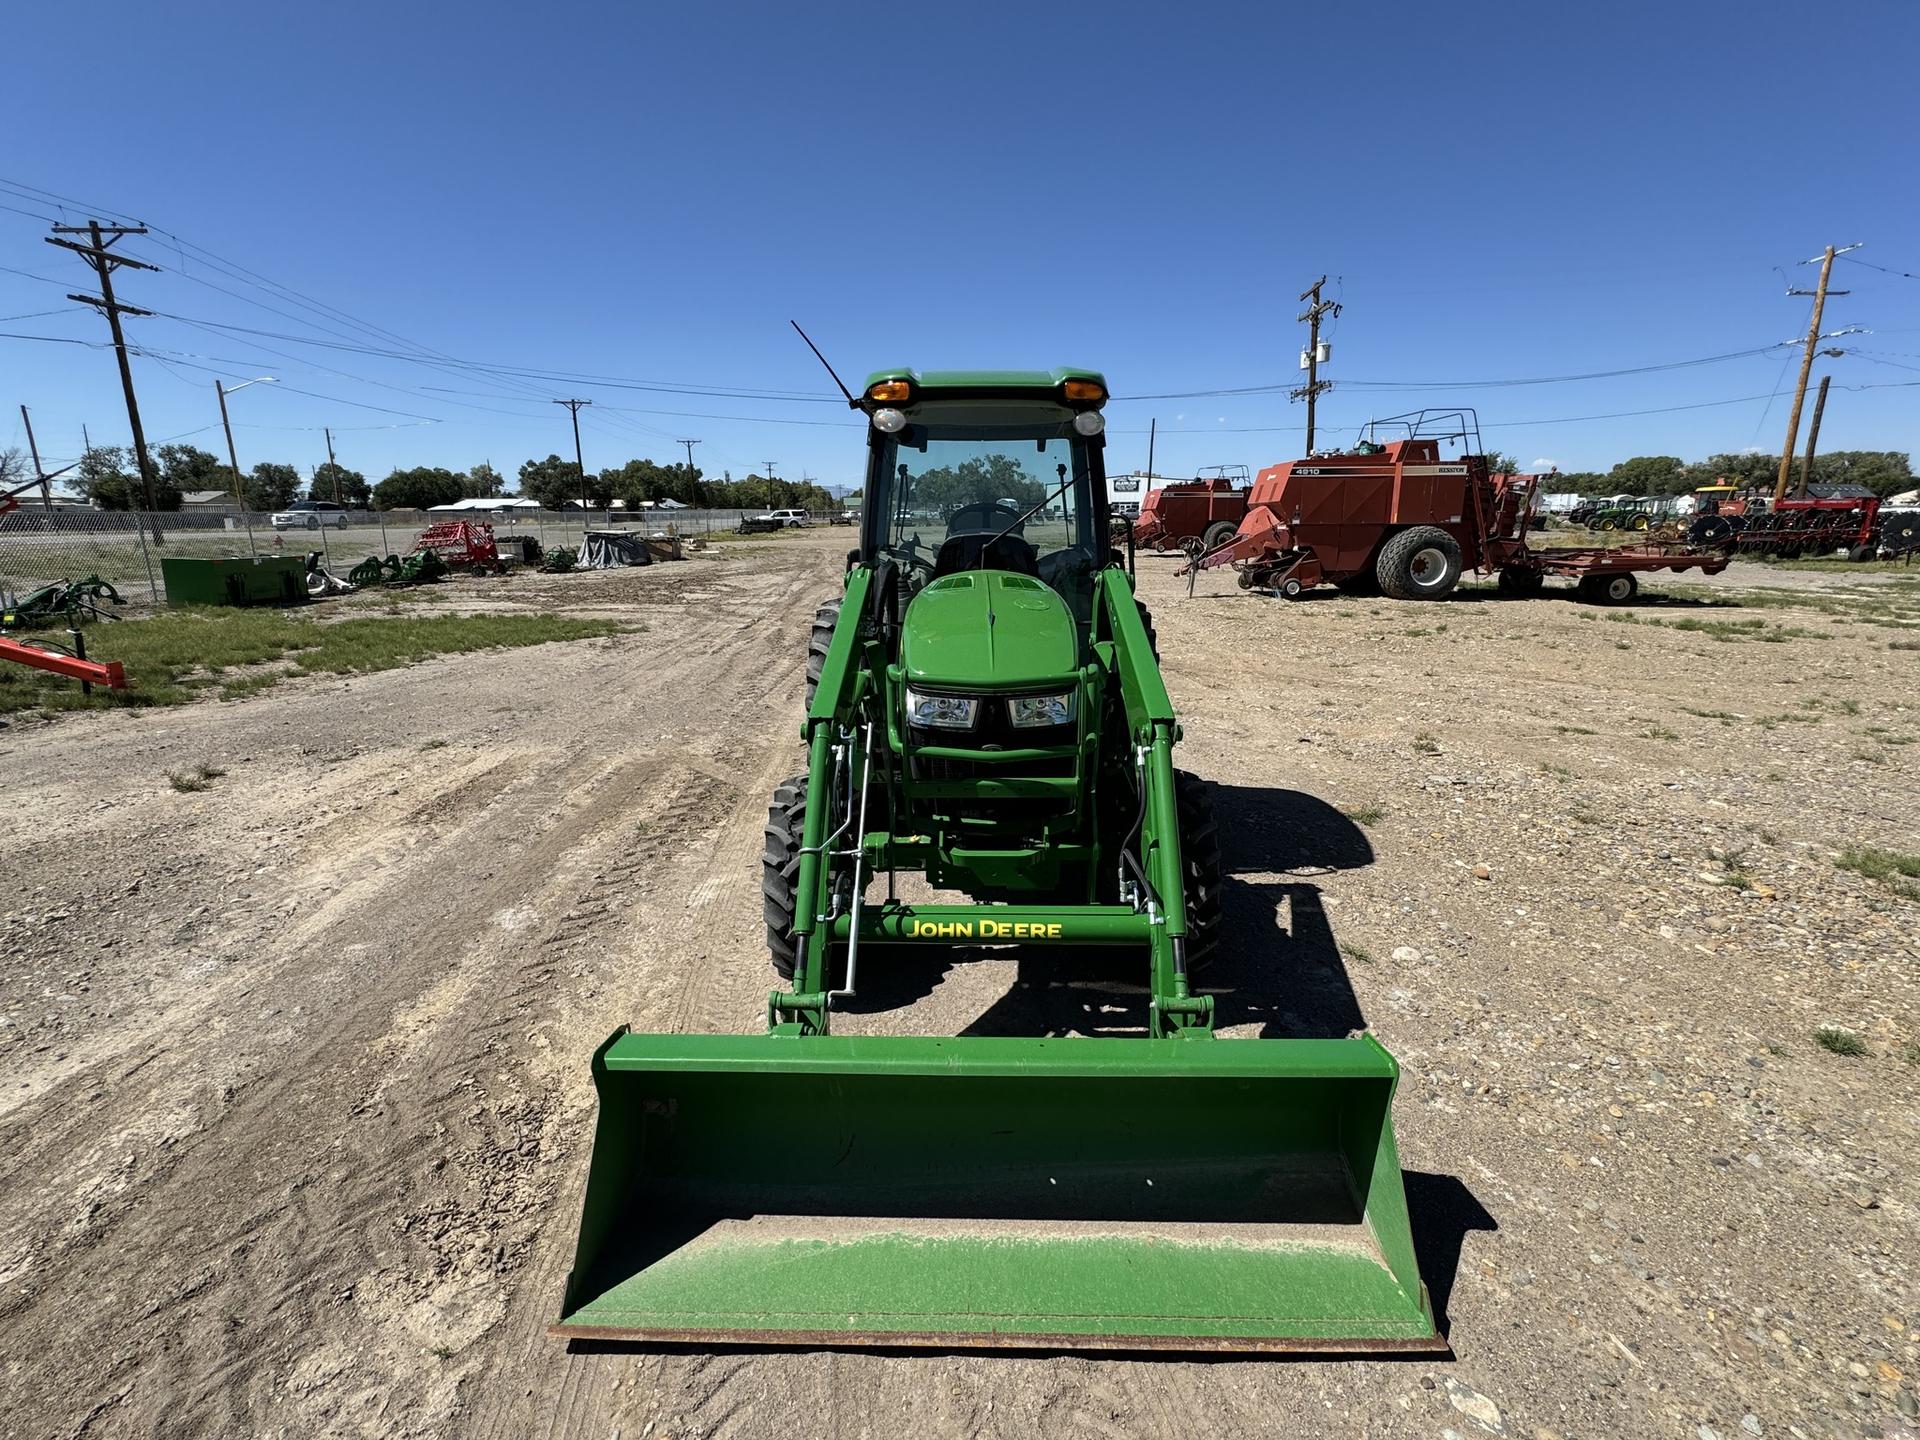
[553,1031,1446,1352]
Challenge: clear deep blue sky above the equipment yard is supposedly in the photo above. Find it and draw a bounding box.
[0,0,1920,484]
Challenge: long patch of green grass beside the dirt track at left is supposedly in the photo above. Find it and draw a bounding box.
[0,609,626,714]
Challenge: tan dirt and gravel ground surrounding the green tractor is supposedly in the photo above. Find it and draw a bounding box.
[0,534,1920,1440]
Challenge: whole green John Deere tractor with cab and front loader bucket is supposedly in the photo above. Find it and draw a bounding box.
[553,371,1444,1352]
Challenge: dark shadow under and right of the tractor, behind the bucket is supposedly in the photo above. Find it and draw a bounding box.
[839,785,1375,1039]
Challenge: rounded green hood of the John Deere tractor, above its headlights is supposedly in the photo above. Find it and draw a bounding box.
[900,570,1079,691]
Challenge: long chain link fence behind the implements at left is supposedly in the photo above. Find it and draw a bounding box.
[0,503,856,609]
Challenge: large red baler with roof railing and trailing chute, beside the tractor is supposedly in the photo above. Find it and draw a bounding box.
[1187,411,1726,603]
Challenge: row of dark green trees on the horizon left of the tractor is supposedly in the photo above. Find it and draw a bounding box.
[73,445,839,511]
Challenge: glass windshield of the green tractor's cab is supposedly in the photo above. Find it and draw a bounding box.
[877,426,1100,603]
